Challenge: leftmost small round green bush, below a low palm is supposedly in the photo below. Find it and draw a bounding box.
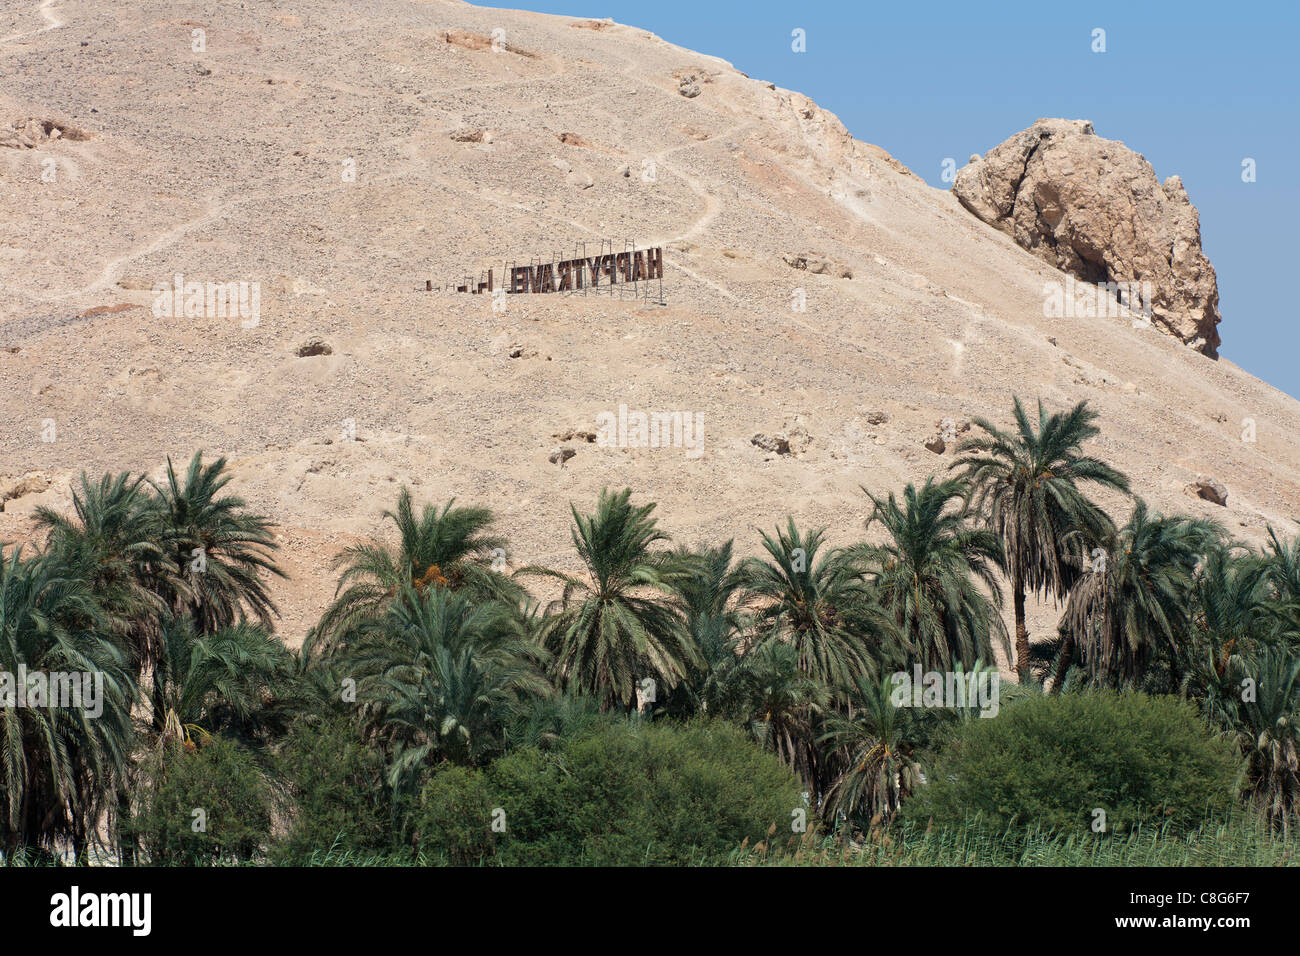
[129,737,272,866]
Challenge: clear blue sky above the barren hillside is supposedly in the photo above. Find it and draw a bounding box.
[484,0,1300,397]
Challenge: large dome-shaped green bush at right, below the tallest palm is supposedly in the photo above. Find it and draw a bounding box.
[904,691,1239,834]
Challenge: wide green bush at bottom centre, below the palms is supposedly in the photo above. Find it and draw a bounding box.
[420,718,803,866]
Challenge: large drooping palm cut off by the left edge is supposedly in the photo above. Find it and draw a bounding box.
[0,548,135,858]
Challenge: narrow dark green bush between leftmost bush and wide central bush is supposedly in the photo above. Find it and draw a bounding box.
[270,718,393,866]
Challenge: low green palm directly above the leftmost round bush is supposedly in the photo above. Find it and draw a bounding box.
[151,614,291,749]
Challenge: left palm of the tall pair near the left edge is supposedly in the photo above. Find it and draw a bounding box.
[36,472,185,676]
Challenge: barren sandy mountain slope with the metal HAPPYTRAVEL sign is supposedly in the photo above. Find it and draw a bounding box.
[0,0,1300,658]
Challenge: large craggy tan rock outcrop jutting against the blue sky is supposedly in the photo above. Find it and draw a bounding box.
[953,120,1219,356]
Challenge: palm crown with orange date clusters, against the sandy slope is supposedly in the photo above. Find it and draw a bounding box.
[317,485,523,646]
